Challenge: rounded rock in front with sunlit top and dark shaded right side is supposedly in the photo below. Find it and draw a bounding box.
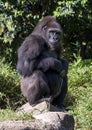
[34,112,74,130]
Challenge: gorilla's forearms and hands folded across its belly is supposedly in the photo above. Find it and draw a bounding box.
[38,57,68,77]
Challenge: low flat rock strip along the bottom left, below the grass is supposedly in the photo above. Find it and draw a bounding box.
[0,121,52,130]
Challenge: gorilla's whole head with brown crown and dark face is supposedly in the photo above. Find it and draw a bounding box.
[33,16,62,50]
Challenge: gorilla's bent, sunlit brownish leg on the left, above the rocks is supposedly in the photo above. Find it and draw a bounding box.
[21,71,50,105]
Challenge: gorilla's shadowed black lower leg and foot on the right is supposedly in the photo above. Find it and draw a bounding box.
[52,76,68,108]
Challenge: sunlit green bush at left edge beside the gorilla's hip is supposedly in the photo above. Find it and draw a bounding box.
[0,58,22,108]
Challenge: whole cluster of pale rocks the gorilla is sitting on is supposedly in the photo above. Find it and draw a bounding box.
[0,101,74,130]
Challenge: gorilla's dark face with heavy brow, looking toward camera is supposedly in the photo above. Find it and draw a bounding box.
[43,22,62,50]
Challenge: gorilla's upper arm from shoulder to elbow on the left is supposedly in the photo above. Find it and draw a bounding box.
[17,35,45,77]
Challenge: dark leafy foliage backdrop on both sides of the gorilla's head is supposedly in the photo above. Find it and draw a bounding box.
[0,0,92,64]
